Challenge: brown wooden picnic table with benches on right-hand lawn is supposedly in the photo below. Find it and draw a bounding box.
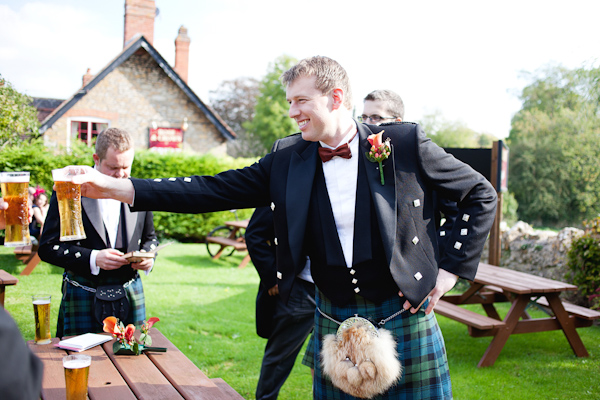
[435,263,600,367]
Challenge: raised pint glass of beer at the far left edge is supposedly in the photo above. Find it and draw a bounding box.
[0,172,31,247]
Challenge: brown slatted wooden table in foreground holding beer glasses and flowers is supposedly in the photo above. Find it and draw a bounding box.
[28,328,243,400]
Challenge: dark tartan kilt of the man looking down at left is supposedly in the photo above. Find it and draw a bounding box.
[56,272,146,338]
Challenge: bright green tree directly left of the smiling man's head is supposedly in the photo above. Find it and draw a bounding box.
[244,55,297,156]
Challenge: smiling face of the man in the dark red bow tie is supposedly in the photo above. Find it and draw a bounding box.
[286,76,337,143]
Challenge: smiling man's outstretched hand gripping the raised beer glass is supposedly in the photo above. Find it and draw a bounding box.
[65,166,135,204]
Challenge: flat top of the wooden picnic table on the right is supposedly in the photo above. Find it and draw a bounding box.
[474,263,577,294]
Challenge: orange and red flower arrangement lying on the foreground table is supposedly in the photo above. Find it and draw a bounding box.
[102,317,161,355]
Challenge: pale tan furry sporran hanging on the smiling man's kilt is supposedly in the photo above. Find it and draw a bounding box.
[321,317,402,399]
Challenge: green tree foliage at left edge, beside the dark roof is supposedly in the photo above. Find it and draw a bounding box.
[0,75,39,147]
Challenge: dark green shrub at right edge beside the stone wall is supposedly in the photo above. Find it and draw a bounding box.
[567,216,600,310]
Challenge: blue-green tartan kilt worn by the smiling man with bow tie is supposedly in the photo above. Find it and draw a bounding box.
[310,290,452,400]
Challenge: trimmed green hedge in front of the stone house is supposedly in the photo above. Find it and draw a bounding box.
[0,140,256,242]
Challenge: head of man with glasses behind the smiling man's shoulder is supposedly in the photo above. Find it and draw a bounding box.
[358,90,404,125]
